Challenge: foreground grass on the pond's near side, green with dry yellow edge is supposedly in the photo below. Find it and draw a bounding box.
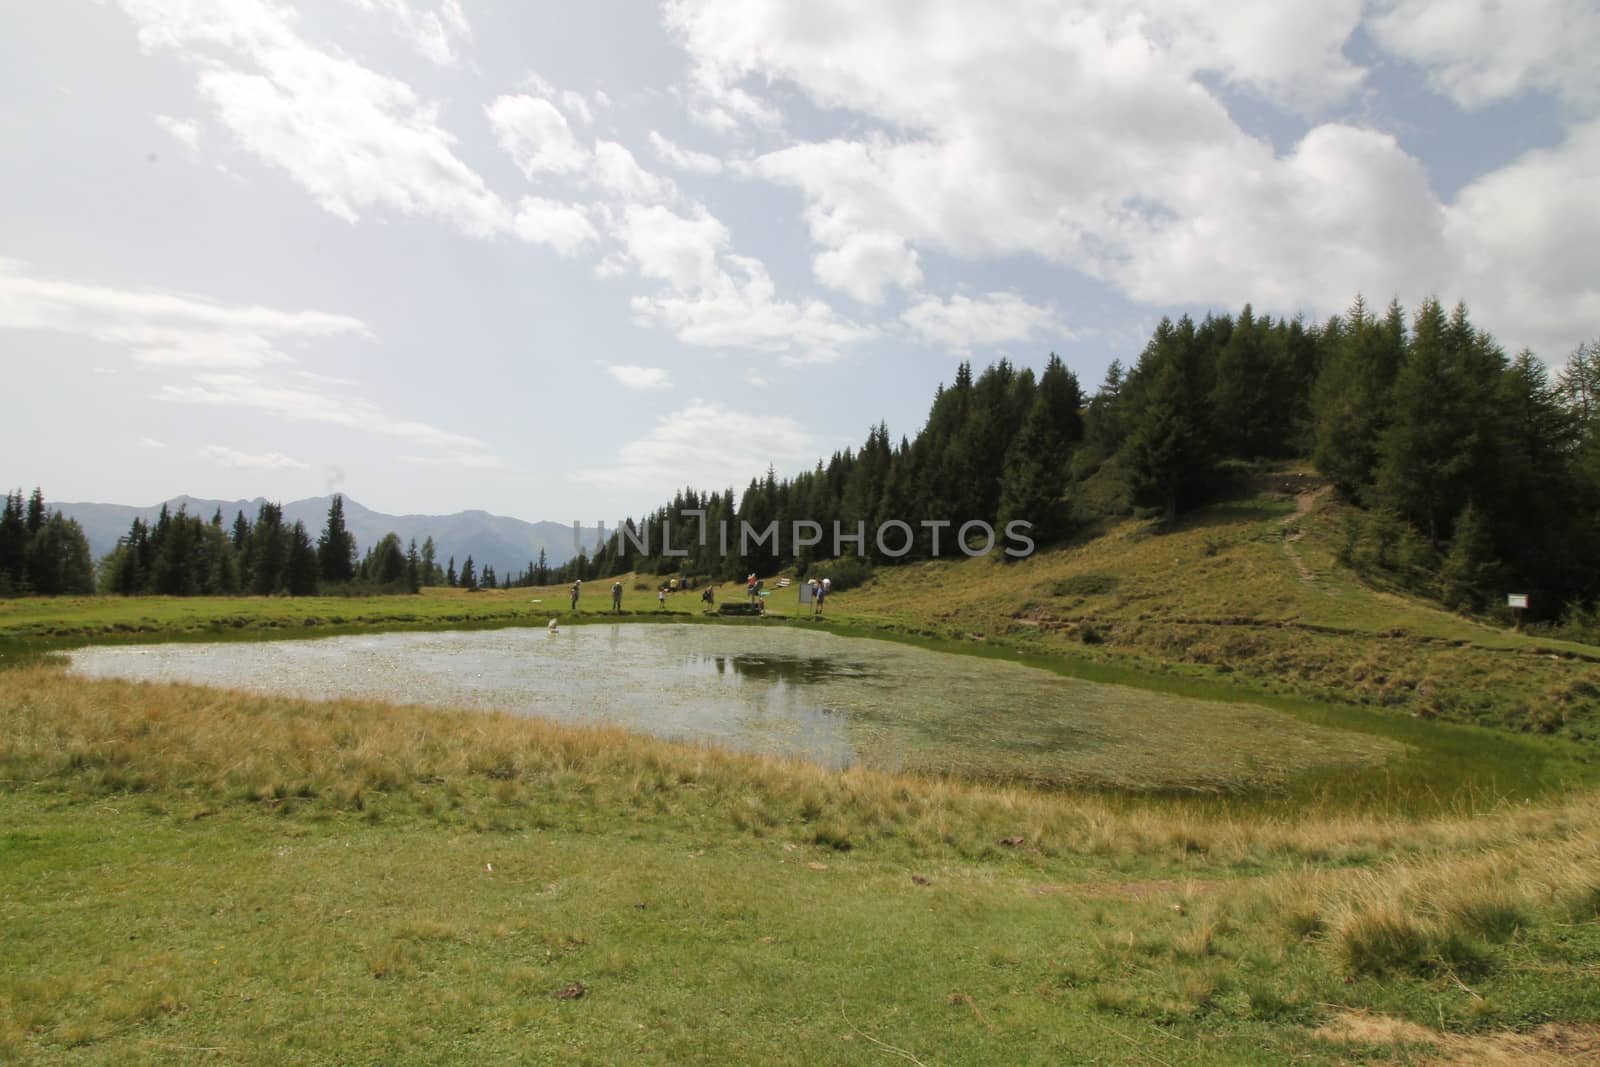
[0,664,1600,1064]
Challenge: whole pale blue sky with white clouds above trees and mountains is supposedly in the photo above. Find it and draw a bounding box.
[0,0,1600,520]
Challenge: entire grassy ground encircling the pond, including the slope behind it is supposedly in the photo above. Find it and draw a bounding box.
[0,489,1600,1065]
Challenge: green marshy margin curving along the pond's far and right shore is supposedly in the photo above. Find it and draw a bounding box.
[9,590,1600,811]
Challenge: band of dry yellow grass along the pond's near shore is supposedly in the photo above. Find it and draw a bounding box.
[9,664,1600,883]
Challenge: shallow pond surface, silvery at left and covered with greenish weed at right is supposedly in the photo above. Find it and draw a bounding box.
[72,624,1398,787]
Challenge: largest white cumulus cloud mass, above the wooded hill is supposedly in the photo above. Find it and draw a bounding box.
[666,0,1600,358]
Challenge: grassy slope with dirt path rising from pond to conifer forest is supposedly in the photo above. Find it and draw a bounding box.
[830,490,1600,741]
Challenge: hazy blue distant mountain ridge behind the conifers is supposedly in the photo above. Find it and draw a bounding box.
[59,496,598,577]
